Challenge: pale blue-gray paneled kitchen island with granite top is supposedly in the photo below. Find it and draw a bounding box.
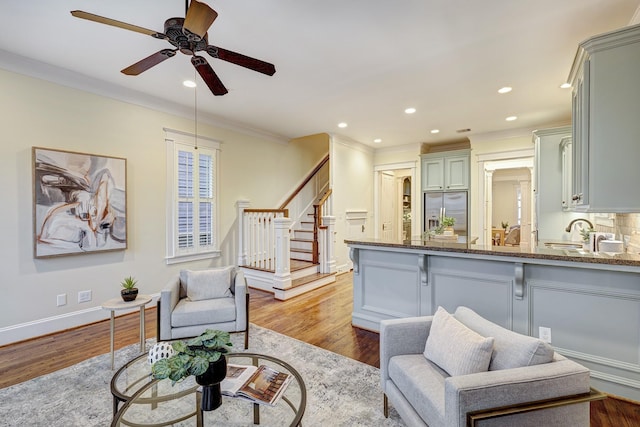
[345,239,640,401]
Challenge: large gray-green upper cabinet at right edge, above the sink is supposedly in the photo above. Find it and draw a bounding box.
[569,25,640,212]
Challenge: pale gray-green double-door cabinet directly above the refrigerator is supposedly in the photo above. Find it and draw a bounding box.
[421,150,470,191]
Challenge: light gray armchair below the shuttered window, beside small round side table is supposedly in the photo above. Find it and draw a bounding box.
[157,266,249,349]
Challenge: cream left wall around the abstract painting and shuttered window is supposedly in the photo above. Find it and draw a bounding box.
[0,70,328,345]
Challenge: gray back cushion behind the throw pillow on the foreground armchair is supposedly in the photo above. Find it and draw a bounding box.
[455,307,554,371]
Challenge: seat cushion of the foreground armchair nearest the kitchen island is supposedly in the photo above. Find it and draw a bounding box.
[389,354,449,427]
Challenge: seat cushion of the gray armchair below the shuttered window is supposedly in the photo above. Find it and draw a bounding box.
[171,297,236,328]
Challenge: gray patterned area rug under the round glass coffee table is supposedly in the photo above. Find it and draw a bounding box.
[0,324,404,427]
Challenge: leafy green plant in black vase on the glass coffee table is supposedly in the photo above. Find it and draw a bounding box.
[151,329,232,411]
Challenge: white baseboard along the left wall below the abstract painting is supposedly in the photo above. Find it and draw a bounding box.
[0,293,160,346]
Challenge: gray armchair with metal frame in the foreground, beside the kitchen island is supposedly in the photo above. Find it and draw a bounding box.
[380,307,604,427]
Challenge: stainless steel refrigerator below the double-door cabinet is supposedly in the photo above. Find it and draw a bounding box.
[422,191,468,237]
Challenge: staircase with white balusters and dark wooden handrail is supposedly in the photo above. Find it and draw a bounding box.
[237,156,336,300]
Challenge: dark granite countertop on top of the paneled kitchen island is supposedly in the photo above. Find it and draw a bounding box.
[344,237,640,267]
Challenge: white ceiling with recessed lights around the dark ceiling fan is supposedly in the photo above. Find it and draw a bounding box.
[0,0,640,149]
